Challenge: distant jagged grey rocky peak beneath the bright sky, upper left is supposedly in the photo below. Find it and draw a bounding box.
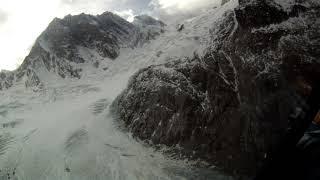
[0,12,164,90]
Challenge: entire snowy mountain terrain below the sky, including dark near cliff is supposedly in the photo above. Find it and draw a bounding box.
[0,0,320,180]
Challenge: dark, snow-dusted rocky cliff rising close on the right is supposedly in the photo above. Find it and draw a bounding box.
[113,0,320,174]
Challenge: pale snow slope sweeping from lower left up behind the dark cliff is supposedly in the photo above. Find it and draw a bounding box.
[0,1,237,180]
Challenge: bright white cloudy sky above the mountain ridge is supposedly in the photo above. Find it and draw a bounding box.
[0,0,220,70]
